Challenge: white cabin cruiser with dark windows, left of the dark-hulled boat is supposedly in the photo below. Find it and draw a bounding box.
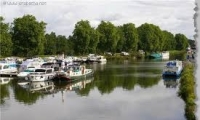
[25,68,56,81]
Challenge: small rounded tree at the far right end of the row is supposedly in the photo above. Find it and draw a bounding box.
[175,33,189,50]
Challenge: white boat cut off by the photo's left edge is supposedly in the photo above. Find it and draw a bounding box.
[0,63,18,76]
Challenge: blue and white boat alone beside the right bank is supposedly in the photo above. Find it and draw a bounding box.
[162,60,183,77]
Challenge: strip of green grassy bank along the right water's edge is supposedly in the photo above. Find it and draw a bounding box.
[178,63,196,120]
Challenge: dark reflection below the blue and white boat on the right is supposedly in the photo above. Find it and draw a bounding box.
[163,77,180,88]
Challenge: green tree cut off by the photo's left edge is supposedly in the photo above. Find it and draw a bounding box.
[0,16,13,56]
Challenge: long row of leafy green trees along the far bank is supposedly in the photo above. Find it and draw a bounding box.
[0,15,189,56]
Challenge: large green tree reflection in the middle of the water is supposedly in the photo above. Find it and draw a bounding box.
[91,61,164,94]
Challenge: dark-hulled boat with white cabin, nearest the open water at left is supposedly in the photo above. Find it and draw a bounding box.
[56,64,93,80]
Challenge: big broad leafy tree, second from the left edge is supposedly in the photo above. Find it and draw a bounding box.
[12,15,46,56]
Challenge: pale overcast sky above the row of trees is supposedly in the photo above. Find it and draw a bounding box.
[0,0,195,39]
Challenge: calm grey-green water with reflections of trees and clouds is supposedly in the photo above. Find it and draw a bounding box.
[0,60,185,120]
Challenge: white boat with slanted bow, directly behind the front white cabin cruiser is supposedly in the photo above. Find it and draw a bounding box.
[17,67,36,80]
